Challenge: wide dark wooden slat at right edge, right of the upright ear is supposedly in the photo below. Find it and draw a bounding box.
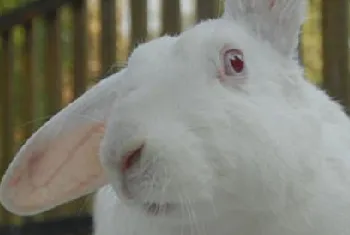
[322,0,350,106]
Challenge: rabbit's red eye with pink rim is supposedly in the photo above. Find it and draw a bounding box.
[223,49,245,76]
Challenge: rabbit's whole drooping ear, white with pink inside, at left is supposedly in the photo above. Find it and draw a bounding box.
[0,71,123,215]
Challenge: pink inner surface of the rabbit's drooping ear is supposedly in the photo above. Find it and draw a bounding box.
[5,124,106,212]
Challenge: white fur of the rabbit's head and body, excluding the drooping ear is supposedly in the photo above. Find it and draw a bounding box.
[3,0,350,235]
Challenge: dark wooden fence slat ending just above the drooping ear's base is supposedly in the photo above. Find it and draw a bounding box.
[100,0,117,74]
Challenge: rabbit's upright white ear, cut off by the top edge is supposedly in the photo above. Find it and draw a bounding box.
[223,0,307,56]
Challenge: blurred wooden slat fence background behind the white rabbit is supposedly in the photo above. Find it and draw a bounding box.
[0,0,350,235]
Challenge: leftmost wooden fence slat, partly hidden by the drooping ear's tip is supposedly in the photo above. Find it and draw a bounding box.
[0,31,14,223]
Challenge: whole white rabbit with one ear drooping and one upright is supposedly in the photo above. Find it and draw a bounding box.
[0,0,350,235]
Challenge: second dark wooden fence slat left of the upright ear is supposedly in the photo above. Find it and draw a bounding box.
[162,0,181,35]
